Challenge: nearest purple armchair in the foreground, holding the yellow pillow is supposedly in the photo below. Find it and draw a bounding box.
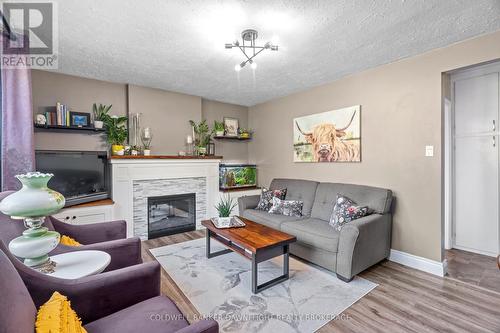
[0,242,219,333]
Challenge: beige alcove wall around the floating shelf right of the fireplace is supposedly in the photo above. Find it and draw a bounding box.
[201,99,248,163]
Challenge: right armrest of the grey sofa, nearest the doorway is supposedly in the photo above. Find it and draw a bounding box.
[337,214,392,281]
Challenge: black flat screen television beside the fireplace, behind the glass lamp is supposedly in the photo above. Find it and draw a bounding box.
[35,150,111,207]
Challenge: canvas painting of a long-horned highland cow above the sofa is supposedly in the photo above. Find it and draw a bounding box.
[293,105,361,162]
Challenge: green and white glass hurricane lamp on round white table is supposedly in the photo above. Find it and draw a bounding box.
[0,172,66,272]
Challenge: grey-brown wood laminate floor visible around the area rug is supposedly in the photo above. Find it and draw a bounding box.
[143,231,500,333]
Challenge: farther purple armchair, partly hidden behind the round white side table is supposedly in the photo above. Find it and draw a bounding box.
[0,191,142,271]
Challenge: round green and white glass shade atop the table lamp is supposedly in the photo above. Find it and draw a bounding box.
[0,172,66,219]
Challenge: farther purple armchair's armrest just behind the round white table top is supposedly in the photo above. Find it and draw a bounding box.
[50,237,142,272]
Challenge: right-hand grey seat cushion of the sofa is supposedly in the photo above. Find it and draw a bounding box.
[281,218,340,253]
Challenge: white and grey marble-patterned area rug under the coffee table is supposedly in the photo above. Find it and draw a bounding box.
[151,239,377,333]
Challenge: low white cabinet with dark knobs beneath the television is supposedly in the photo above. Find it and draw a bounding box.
[54,205,113,225]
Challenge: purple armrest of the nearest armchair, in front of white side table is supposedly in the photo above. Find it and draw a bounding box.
[23,262,161,323]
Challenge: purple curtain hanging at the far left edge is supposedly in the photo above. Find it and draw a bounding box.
[1,39,35,191]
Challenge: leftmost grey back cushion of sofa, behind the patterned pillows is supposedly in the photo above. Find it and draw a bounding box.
[269,178,318,216]
